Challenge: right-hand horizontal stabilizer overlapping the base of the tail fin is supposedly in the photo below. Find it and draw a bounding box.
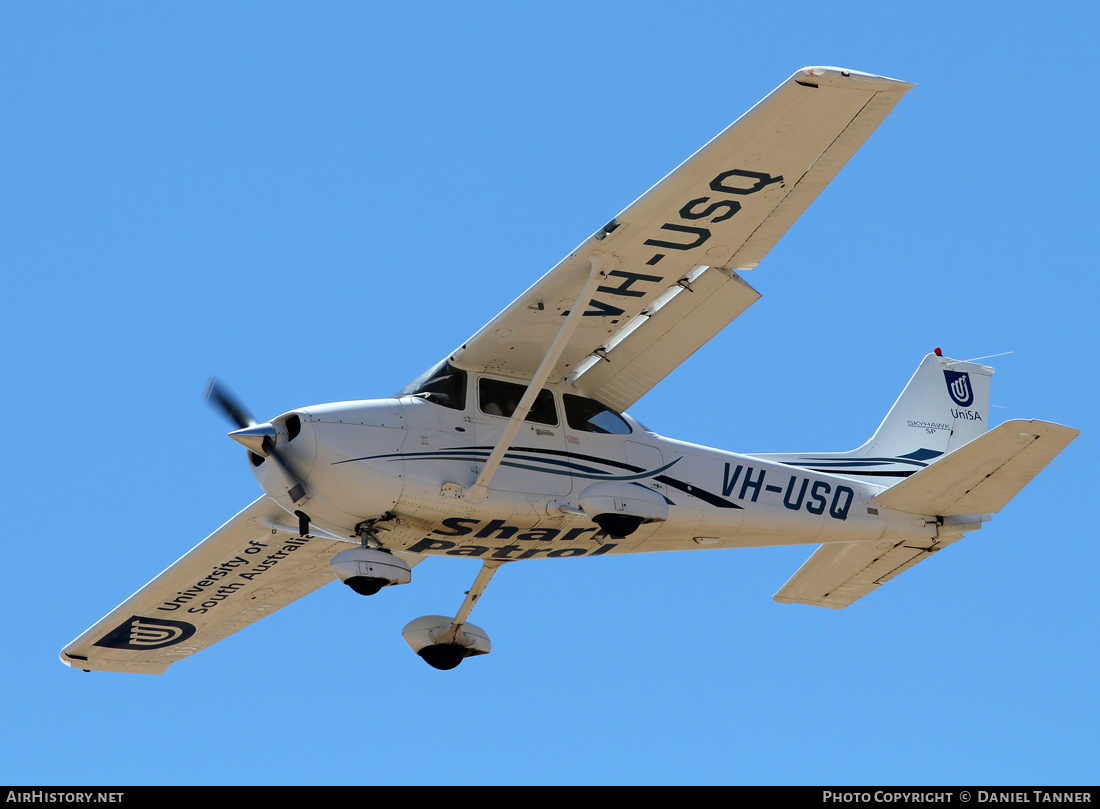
[876,418,1080,516]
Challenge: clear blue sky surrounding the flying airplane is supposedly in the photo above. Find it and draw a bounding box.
[0,2,1100,784]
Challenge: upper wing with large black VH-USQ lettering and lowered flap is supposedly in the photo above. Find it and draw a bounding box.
[451,67,913,411]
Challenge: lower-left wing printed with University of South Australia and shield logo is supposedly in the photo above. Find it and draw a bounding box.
[61,495,424,674]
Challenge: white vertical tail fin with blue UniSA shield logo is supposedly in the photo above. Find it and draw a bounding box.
[759,354,993,485]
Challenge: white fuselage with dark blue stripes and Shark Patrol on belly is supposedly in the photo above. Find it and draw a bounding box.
[253,374,936,560]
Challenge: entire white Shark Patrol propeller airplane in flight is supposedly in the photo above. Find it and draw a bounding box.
[62,67,1078,674]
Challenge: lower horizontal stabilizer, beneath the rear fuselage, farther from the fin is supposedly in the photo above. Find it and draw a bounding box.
[772,536,960,610]
